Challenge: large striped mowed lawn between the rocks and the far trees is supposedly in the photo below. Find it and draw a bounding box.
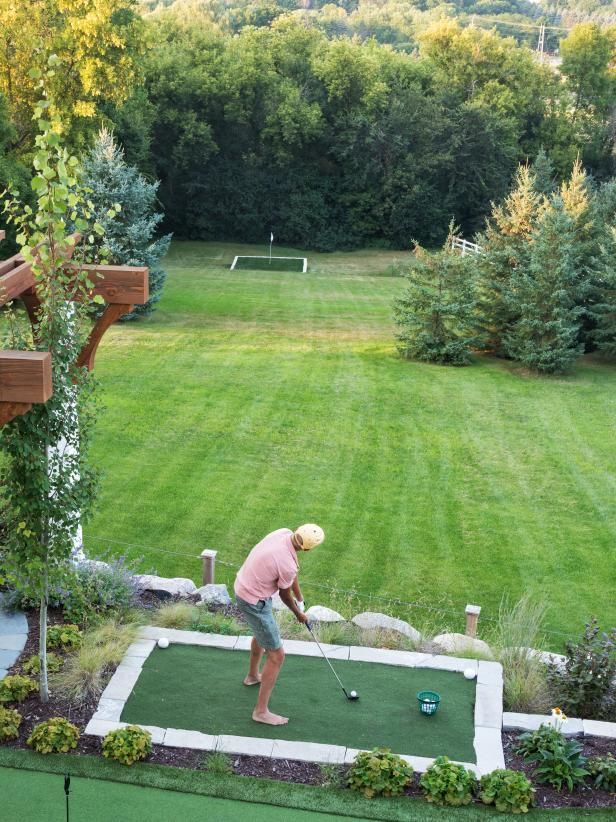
[86,243,616,647]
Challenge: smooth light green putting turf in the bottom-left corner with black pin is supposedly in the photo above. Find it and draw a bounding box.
[0,768,366,822]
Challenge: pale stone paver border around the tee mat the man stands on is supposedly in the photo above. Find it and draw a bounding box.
[85,626,505,776]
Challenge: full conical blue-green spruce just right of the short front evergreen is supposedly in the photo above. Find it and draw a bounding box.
[504,201,584,374]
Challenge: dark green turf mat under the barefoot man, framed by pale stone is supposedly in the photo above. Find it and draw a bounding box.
[121,645,475,762]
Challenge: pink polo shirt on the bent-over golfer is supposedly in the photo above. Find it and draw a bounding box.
[234,528,299,605]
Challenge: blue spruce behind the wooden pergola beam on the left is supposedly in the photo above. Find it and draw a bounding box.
[84,129,171,319]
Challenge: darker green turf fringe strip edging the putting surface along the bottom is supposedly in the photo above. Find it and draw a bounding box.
[0,746,614,822]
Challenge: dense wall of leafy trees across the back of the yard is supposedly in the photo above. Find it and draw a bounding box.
[0,0,616,250]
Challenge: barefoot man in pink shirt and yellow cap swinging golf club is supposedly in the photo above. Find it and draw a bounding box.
[235,524,325,725]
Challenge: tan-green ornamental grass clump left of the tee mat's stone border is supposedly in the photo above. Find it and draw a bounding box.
[51,620,137,702]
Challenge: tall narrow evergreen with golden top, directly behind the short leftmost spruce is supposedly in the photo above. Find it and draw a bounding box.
[477,166,543,356]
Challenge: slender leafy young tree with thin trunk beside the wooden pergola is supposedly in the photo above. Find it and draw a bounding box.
[0,56,116,702]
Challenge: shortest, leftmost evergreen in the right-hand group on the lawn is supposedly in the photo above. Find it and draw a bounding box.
[394,227,479,365]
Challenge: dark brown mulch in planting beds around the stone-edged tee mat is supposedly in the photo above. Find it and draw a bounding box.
[4,595,616,809]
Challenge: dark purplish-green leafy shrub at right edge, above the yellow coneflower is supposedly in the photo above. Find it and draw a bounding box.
[549,619,616,719]
